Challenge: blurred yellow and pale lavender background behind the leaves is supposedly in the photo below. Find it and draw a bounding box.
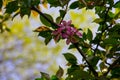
[0,1,98,80]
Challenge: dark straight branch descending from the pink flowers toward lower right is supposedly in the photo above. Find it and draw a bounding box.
[74,43,98,77]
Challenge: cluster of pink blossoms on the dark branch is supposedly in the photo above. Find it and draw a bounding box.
[52,20,82,44]
